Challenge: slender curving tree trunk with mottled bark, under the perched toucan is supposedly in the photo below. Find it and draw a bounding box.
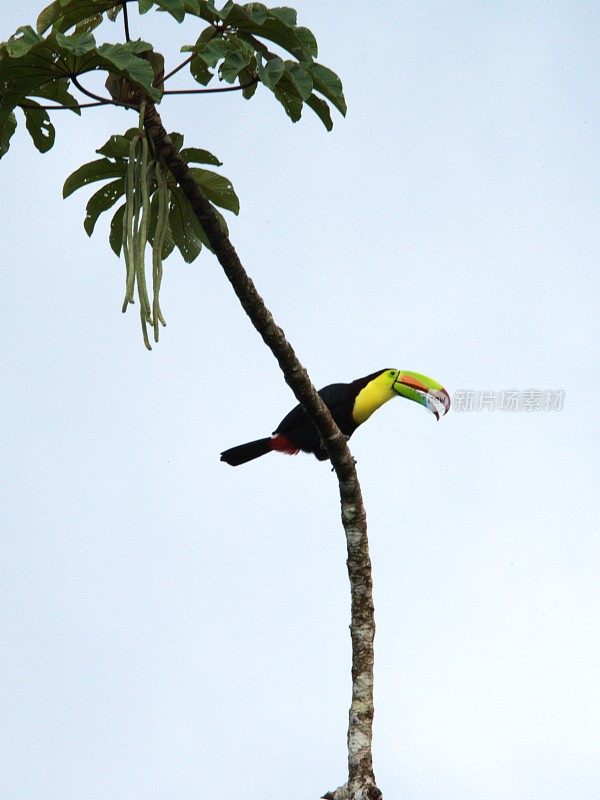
[145,103,381,800]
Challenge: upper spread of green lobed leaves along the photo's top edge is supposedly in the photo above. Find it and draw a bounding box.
[0,0,346,158]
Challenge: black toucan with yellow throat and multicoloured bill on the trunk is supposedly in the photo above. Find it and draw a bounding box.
[221,369,450,467]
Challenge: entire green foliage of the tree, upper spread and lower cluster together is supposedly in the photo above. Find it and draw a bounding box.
[0,0,346,340]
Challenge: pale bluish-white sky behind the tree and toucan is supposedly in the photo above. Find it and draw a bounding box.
[0,0,600,800]
